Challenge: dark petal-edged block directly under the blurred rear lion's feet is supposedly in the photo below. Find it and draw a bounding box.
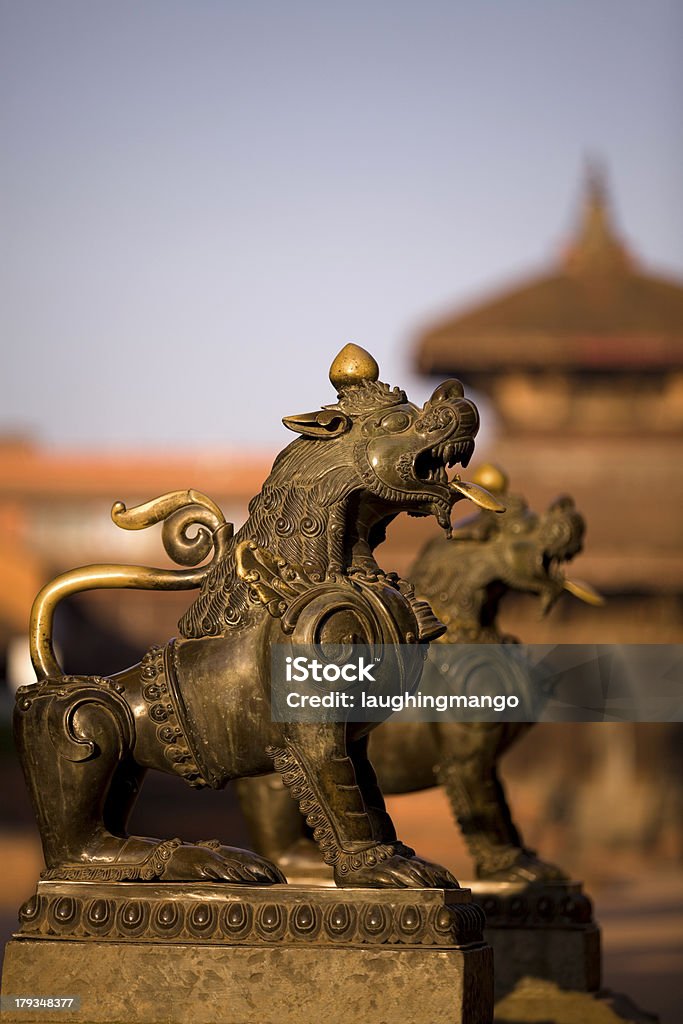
[468,882,600,1001]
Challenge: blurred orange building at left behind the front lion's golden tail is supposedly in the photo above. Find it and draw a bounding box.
[0,438,271,687]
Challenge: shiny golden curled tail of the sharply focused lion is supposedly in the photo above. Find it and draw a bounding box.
[29,490,232,679]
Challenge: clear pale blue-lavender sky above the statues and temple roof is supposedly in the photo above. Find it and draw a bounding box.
[0,0,683,447]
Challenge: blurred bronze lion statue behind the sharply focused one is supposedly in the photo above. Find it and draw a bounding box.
[238,465,601,882]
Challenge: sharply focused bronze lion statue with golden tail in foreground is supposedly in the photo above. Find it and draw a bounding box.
[14,345,502,888]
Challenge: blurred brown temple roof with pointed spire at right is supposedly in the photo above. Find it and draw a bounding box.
[416,170,683,374]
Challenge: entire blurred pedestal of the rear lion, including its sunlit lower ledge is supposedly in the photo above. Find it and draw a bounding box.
[465,881,657,1024]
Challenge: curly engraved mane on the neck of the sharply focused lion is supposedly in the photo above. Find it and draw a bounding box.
[178,438,359,638]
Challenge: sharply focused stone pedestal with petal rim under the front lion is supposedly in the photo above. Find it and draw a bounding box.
[2,882,493,1024]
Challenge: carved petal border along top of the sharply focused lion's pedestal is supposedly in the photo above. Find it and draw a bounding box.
[17,885,484,948]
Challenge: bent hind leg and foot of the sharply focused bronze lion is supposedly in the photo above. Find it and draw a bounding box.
[14,677,283,885]
